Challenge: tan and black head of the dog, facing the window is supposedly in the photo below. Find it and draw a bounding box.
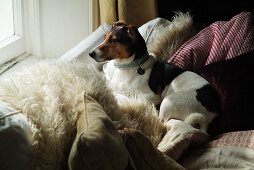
[89,22,147,62]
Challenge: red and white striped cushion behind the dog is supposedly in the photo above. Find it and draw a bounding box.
[168,12,254,71]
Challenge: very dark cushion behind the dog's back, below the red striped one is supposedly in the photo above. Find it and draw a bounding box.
[200,51,254,134]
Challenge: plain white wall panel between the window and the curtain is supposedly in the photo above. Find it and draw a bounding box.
[40,0,89,57]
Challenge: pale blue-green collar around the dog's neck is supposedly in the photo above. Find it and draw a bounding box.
[114,54,149,69]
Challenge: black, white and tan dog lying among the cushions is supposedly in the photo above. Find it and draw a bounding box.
[89,21,220,133]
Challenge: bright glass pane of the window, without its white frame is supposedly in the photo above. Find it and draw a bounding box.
[0,0,14,42]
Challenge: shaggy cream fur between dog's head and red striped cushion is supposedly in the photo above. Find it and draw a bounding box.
[147,12,195,60]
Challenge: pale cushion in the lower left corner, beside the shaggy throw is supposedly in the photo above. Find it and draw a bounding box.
[0,101,32,170]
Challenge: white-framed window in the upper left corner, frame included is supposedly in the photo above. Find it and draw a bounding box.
[0,0,26,65]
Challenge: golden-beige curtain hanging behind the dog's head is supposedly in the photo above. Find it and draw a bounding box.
[93,0,157,30]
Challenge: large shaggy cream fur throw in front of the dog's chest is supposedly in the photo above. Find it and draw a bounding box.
[0,60,165,170]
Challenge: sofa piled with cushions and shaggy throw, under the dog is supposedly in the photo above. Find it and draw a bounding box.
[0,5,254,170]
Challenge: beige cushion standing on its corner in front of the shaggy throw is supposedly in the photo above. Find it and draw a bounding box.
[69,94,133,170]
